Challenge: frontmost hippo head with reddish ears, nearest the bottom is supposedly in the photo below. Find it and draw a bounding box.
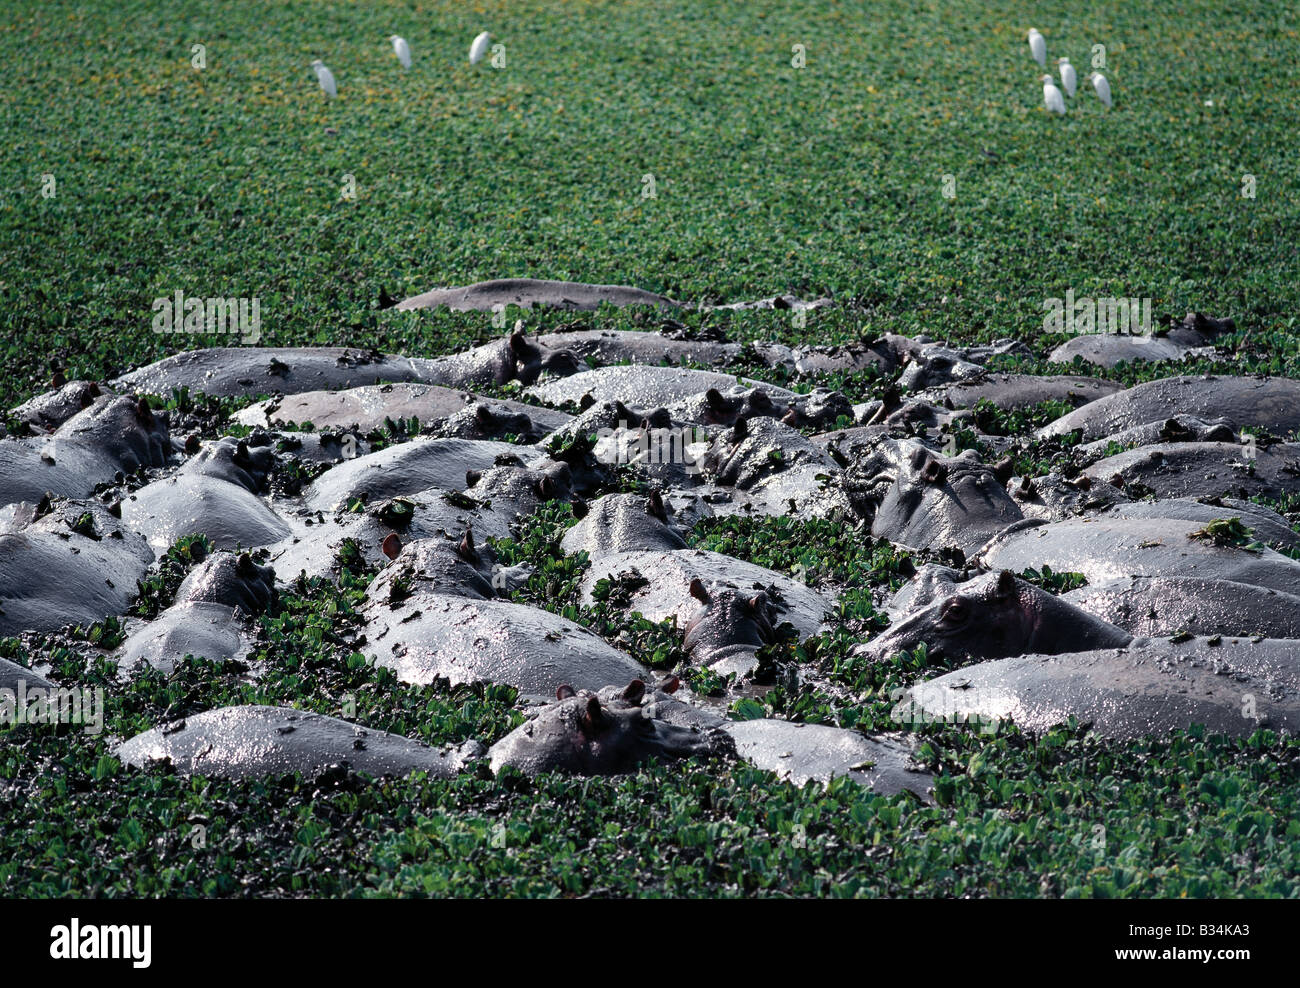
[488,680,735,775]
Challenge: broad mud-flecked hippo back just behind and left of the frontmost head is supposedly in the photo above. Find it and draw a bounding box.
[361,582,645,697]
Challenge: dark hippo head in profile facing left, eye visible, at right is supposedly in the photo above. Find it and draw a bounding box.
[855,569,1132,662]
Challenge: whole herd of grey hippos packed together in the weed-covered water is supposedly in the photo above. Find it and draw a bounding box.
[0,281,1300,798]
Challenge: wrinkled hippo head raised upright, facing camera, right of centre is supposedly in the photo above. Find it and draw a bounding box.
[871,443,1023,554]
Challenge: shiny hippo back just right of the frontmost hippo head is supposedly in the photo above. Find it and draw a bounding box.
[723,719,935,802]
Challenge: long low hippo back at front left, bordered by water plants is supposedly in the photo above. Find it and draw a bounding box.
[116,706,476,779]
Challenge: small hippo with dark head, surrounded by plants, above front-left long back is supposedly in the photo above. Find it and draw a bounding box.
[117,553,276,673]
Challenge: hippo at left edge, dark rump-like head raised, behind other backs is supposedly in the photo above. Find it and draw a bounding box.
[0,395,172,506]
